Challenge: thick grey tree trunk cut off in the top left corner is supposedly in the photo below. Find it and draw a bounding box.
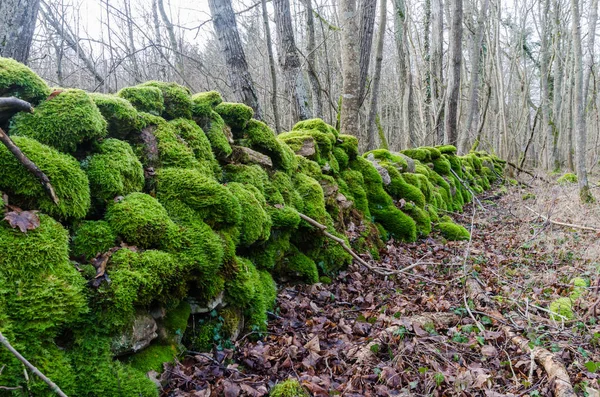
[0,0,40,64]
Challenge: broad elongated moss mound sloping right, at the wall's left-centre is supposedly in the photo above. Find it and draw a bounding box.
[156,168,241,229]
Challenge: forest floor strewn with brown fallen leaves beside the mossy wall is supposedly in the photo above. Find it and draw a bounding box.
[163,177,600,397]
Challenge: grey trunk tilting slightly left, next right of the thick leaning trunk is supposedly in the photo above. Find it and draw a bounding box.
[273,0,311,123]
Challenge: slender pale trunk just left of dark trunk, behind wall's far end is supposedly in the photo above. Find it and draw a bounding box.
[430,0,444,144]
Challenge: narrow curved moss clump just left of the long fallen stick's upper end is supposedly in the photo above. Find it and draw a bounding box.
[227,182,271,246]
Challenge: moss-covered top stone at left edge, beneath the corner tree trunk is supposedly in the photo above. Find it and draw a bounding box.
[0,57,51,105]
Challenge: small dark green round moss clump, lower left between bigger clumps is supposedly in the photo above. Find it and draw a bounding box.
[71,221,117,260]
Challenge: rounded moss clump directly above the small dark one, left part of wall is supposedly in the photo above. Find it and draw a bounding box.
[81,138,144,203]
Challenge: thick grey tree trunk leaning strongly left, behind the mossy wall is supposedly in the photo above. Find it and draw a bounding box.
[208,0,262,120]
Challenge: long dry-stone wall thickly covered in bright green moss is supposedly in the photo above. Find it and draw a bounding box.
[0,58,503,396]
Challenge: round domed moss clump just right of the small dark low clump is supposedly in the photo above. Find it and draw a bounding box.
[106,193,174,248]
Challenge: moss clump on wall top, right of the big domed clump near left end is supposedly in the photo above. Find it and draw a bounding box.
[90,93,144,139]
